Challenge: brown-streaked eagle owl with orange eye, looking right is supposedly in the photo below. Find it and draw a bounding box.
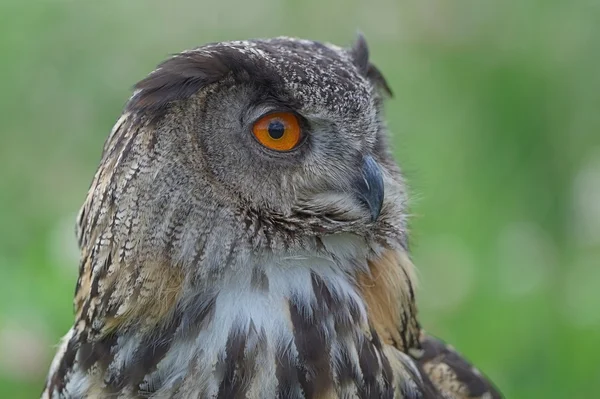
[42,37,501,399]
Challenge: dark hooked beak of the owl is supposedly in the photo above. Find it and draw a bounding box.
[354,155,383,222]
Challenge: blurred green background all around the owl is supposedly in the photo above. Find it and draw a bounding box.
[0,0,600,399]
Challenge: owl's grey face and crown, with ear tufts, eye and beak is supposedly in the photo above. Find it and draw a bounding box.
[127,38,403,245]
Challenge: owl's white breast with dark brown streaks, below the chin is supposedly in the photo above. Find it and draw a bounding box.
[48,235,416,398]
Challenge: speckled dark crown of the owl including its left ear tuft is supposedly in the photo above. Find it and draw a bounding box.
[127,38,373,119]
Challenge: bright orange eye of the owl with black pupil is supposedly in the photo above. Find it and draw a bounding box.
[252,112,301,151]
